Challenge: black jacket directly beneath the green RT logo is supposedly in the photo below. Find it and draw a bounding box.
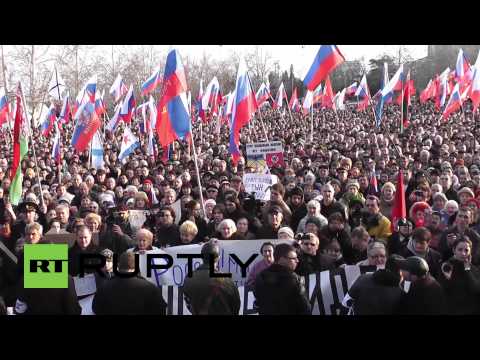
[18,276,82,315]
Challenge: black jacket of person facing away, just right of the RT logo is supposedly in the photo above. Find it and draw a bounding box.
[92,276,167,315]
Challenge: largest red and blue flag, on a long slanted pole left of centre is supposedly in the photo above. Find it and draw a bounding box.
[156,49,191,146]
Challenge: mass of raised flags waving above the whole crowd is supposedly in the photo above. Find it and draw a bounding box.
[0,45,480,207]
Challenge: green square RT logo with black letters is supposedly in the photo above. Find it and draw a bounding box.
[23,244,68,289]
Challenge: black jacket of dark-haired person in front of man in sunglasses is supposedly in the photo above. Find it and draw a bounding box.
[254,264,311,315]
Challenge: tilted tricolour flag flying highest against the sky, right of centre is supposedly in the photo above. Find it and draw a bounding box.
[303,45,345,91]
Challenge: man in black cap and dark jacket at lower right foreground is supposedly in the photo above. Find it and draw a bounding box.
[397,256,447,315]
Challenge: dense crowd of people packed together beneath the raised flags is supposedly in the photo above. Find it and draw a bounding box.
[0,95,480,314]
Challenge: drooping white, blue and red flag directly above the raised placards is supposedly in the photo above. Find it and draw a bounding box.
[229,58,258,165]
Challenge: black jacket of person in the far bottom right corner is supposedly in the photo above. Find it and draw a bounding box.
[438,258,480,315]
